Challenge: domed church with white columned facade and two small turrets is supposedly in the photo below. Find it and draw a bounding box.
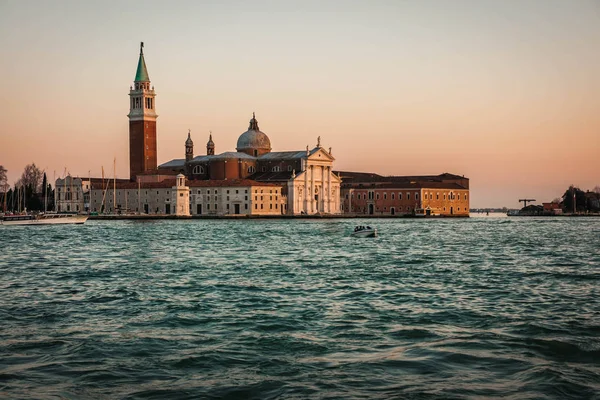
[159,115,341,215]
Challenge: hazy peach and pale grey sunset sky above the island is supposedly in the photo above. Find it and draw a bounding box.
[0,0,600,208]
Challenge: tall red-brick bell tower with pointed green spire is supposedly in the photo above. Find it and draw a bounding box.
[127,42,158,181]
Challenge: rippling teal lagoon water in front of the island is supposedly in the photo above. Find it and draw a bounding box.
[0,218,600,399]
